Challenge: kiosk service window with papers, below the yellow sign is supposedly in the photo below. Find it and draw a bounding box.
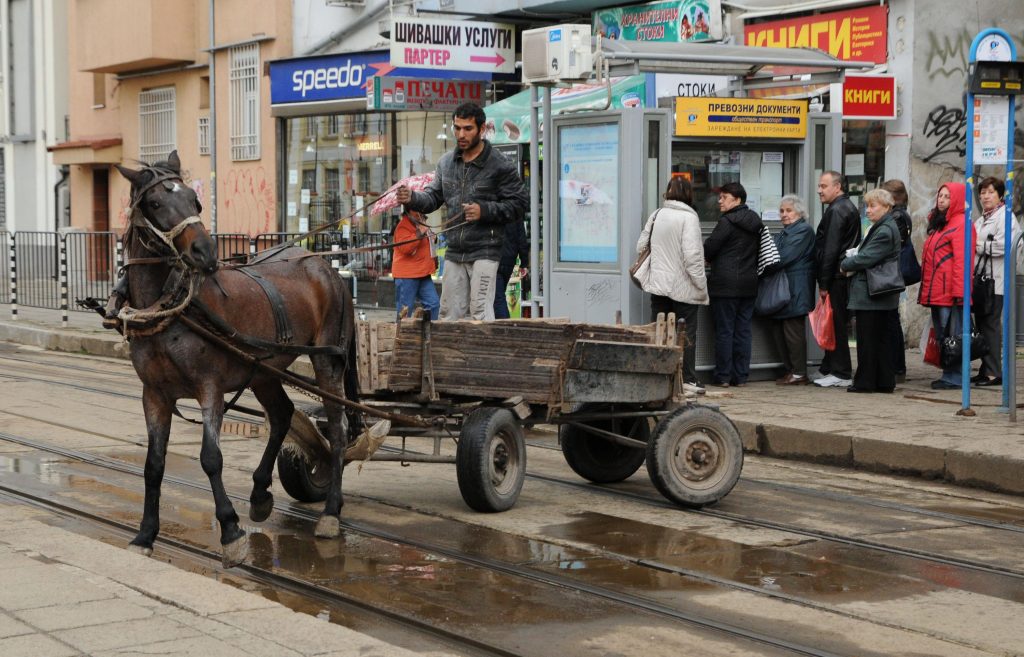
[672,143,797,223]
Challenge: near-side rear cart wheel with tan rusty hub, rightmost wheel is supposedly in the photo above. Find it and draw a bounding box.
[647,406,743,508]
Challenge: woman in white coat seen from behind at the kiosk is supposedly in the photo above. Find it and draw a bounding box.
[637,176,708,394]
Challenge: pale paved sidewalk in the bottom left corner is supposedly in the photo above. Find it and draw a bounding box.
[0,502,442,657]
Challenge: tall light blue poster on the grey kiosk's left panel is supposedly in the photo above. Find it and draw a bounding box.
[558,123,618,263]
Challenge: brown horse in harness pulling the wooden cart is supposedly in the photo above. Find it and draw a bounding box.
[118,151,355,566]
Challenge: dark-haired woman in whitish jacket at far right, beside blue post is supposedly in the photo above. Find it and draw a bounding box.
[971,176,1021,387]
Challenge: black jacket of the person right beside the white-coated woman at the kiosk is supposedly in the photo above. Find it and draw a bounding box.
[705,204,764,297]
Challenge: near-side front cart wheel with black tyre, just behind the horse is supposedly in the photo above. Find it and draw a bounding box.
[456,407,526,512]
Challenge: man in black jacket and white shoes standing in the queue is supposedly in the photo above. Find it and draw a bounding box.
[814,171,860,388]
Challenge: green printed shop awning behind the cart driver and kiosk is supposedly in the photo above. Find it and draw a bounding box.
[483,76,647,143]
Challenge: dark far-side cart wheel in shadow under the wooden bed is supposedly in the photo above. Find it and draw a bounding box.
[558,407,650,484]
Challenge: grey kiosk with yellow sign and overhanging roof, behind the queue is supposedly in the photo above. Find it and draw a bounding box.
[531,40,870,377]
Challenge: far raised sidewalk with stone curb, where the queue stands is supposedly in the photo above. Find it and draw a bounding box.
[6,308,1024,493]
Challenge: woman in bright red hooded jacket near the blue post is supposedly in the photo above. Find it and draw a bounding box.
[918,182,974,390]
